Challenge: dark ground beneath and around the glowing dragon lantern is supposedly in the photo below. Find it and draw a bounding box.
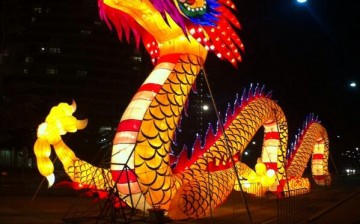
[0,176,360,224]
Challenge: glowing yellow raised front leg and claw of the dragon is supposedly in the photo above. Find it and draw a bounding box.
[34,102,111,192]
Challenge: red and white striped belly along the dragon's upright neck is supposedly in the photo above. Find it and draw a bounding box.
[111,62,175,194]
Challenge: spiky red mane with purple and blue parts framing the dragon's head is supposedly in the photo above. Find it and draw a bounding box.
[98,0,244,66]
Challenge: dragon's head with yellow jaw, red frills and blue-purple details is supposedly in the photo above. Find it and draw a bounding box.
[98,0,243,66]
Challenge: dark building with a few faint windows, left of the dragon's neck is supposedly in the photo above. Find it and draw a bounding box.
[0,0,151,174]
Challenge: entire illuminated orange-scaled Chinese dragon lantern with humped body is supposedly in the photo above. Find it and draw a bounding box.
[34,0,329,219]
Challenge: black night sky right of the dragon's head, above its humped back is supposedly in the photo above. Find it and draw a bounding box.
[201,0,360,150]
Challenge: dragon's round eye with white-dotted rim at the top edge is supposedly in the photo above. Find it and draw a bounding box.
[177,0,206,17]
